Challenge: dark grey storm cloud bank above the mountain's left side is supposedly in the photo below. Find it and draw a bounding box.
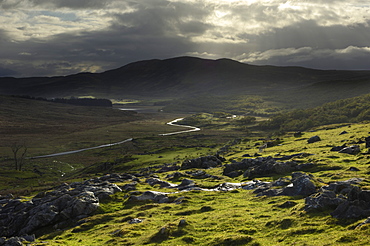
[0,1,208,75]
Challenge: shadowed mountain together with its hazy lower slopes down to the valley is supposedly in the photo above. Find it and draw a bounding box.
[0,57,370,115]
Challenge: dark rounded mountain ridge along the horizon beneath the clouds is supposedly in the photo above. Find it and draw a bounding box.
[0,57,370,98]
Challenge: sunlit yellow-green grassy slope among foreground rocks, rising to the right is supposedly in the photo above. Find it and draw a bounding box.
[36,124,370,245]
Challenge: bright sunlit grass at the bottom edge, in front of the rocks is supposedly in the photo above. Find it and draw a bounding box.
[39,177,369,245]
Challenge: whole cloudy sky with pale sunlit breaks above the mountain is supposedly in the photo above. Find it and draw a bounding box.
[0,0,370,77]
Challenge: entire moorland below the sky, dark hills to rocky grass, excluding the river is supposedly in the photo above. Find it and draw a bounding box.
[0,57,370,245]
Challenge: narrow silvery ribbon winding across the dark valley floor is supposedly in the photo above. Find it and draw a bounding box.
[28,118,200,159]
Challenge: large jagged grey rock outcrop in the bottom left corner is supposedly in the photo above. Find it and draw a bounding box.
[0,177,122,237]
